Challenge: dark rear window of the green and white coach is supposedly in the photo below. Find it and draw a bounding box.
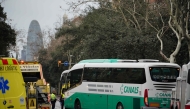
[149,67,179,82]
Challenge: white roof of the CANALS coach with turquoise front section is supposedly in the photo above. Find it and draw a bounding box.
[70,59,180,70]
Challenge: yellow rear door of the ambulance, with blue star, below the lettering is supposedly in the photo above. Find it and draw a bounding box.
[2,71,26,109]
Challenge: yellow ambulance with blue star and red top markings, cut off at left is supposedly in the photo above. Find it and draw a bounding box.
[0,57,27,109]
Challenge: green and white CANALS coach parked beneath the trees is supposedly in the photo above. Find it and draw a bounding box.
[60,59,181,109]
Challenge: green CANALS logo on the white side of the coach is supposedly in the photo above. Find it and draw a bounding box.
[120,84,139,94]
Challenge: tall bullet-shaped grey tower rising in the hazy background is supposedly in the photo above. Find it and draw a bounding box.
[26,20,43,61]
